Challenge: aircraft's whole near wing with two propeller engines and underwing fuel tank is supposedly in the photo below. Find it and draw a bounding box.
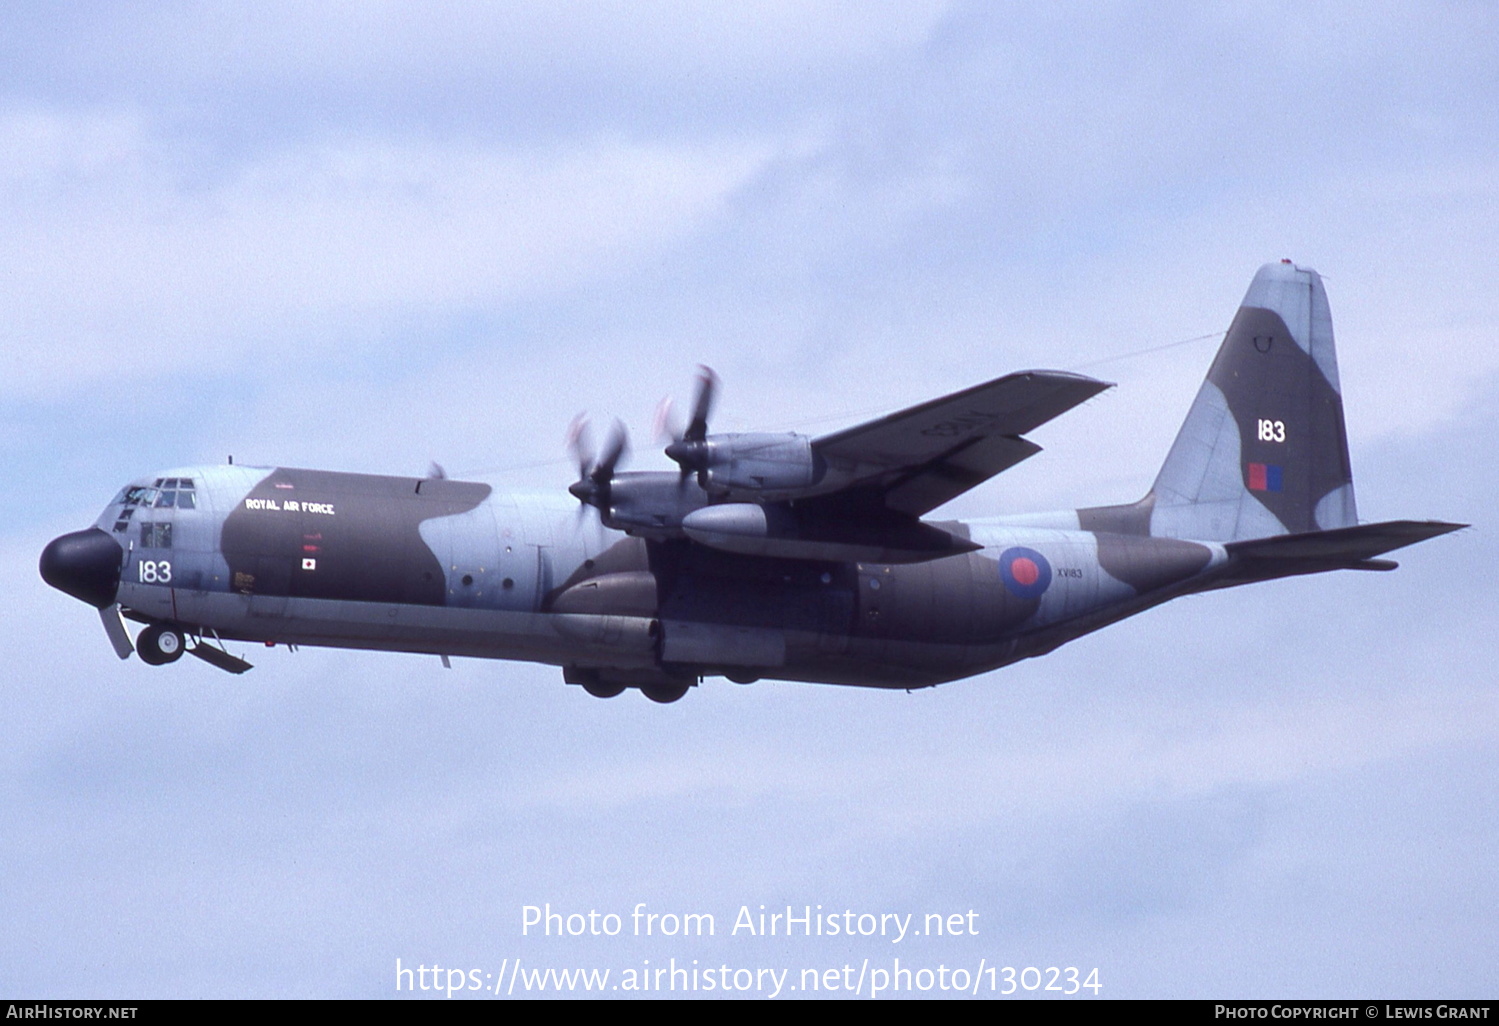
[584,368,1109,563]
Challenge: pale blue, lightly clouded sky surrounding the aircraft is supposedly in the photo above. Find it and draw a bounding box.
[0,0,1499,999]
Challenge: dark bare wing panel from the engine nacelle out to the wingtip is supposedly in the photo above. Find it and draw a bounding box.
[808,371,1112,516]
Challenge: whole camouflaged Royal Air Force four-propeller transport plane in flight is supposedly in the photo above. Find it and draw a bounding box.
[40,261,1465,702]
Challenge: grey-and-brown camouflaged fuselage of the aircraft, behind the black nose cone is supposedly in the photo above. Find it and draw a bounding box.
[43,465,1225,687]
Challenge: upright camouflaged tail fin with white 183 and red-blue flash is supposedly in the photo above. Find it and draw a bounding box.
[1081,261,1358,542]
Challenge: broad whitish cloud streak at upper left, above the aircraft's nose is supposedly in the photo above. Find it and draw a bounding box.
[0,111,766,396]
